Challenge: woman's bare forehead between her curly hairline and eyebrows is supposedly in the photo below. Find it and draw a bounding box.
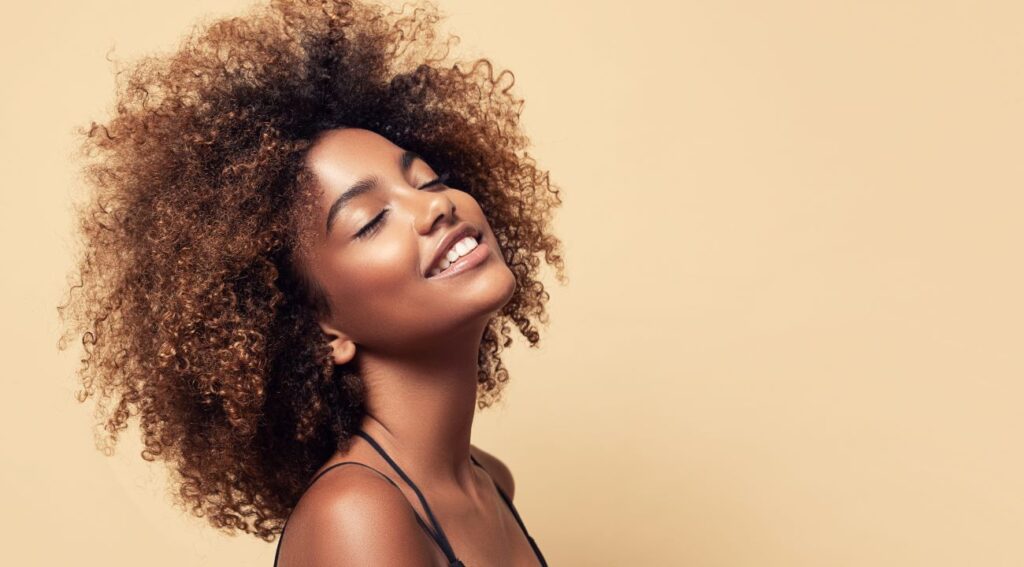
[306,128,401,187]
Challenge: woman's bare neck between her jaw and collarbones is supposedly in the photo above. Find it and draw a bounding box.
[359,321,482,494]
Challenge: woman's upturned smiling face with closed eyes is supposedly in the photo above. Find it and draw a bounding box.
[305,128,515,350]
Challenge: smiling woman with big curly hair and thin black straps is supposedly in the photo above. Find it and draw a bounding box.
[60,1,565,567]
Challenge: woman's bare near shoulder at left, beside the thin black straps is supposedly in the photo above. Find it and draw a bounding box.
[278,465,433,567]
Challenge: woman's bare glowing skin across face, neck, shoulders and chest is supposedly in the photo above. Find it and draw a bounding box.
[279,128,538,567]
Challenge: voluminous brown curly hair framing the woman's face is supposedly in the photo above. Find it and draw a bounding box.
[57,0,566,541]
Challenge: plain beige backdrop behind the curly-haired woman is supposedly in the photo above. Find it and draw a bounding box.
[0,0,1024,567]
